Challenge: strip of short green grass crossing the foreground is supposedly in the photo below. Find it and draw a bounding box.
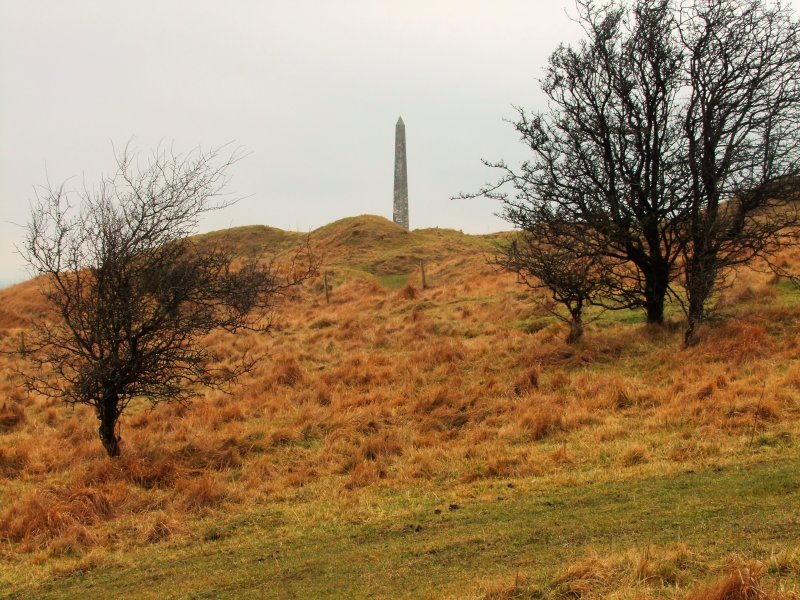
[5,455,800,598]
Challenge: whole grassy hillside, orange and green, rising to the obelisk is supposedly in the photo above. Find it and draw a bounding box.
[0,216,800,599]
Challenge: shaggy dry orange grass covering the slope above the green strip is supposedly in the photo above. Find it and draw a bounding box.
[0,217,800,598]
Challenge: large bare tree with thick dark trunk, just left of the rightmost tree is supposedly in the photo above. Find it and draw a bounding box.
[468,0,682,323]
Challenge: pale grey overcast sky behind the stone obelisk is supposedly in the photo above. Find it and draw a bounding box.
[0,0,792,285]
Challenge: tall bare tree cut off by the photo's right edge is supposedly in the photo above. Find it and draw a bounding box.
[678,0,800,344]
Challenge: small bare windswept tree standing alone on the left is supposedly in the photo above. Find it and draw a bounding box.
[21,148,314,456]
